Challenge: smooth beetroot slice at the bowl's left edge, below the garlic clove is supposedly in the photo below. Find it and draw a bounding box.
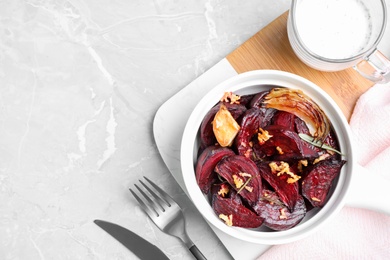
[195,146,234,194]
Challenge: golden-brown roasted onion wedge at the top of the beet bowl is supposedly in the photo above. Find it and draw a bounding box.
[263,88,330,142]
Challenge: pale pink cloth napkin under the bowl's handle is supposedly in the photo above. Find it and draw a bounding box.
[258,84,390,260]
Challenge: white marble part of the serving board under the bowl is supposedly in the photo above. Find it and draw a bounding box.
[153,58,271,260]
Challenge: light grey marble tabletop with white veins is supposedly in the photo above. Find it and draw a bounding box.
[0,0,390,259]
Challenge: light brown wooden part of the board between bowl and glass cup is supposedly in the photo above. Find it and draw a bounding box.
[226,12,374,120]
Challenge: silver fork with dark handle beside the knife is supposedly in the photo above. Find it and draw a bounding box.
[129,176,206,259]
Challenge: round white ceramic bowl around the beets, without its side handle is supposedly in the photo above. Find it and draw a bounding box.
[181,70,354,245]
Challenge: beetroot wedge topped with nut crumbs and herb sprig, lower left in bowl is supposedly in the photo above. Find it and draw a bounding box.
[215,155,262,205]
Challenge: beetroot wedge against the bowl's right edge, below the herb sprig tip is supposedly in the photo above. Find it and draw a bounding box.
[302,159,346,207]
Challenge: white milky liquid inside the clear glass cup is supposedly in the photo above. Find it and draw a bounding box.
[296,0,372,59]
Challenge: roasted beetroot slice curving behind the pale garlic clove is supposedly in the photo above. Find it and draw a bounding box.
[200,102,246,149]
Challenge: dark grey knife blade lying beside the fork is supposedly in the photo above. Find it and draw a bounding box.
[93,219,169,260]
